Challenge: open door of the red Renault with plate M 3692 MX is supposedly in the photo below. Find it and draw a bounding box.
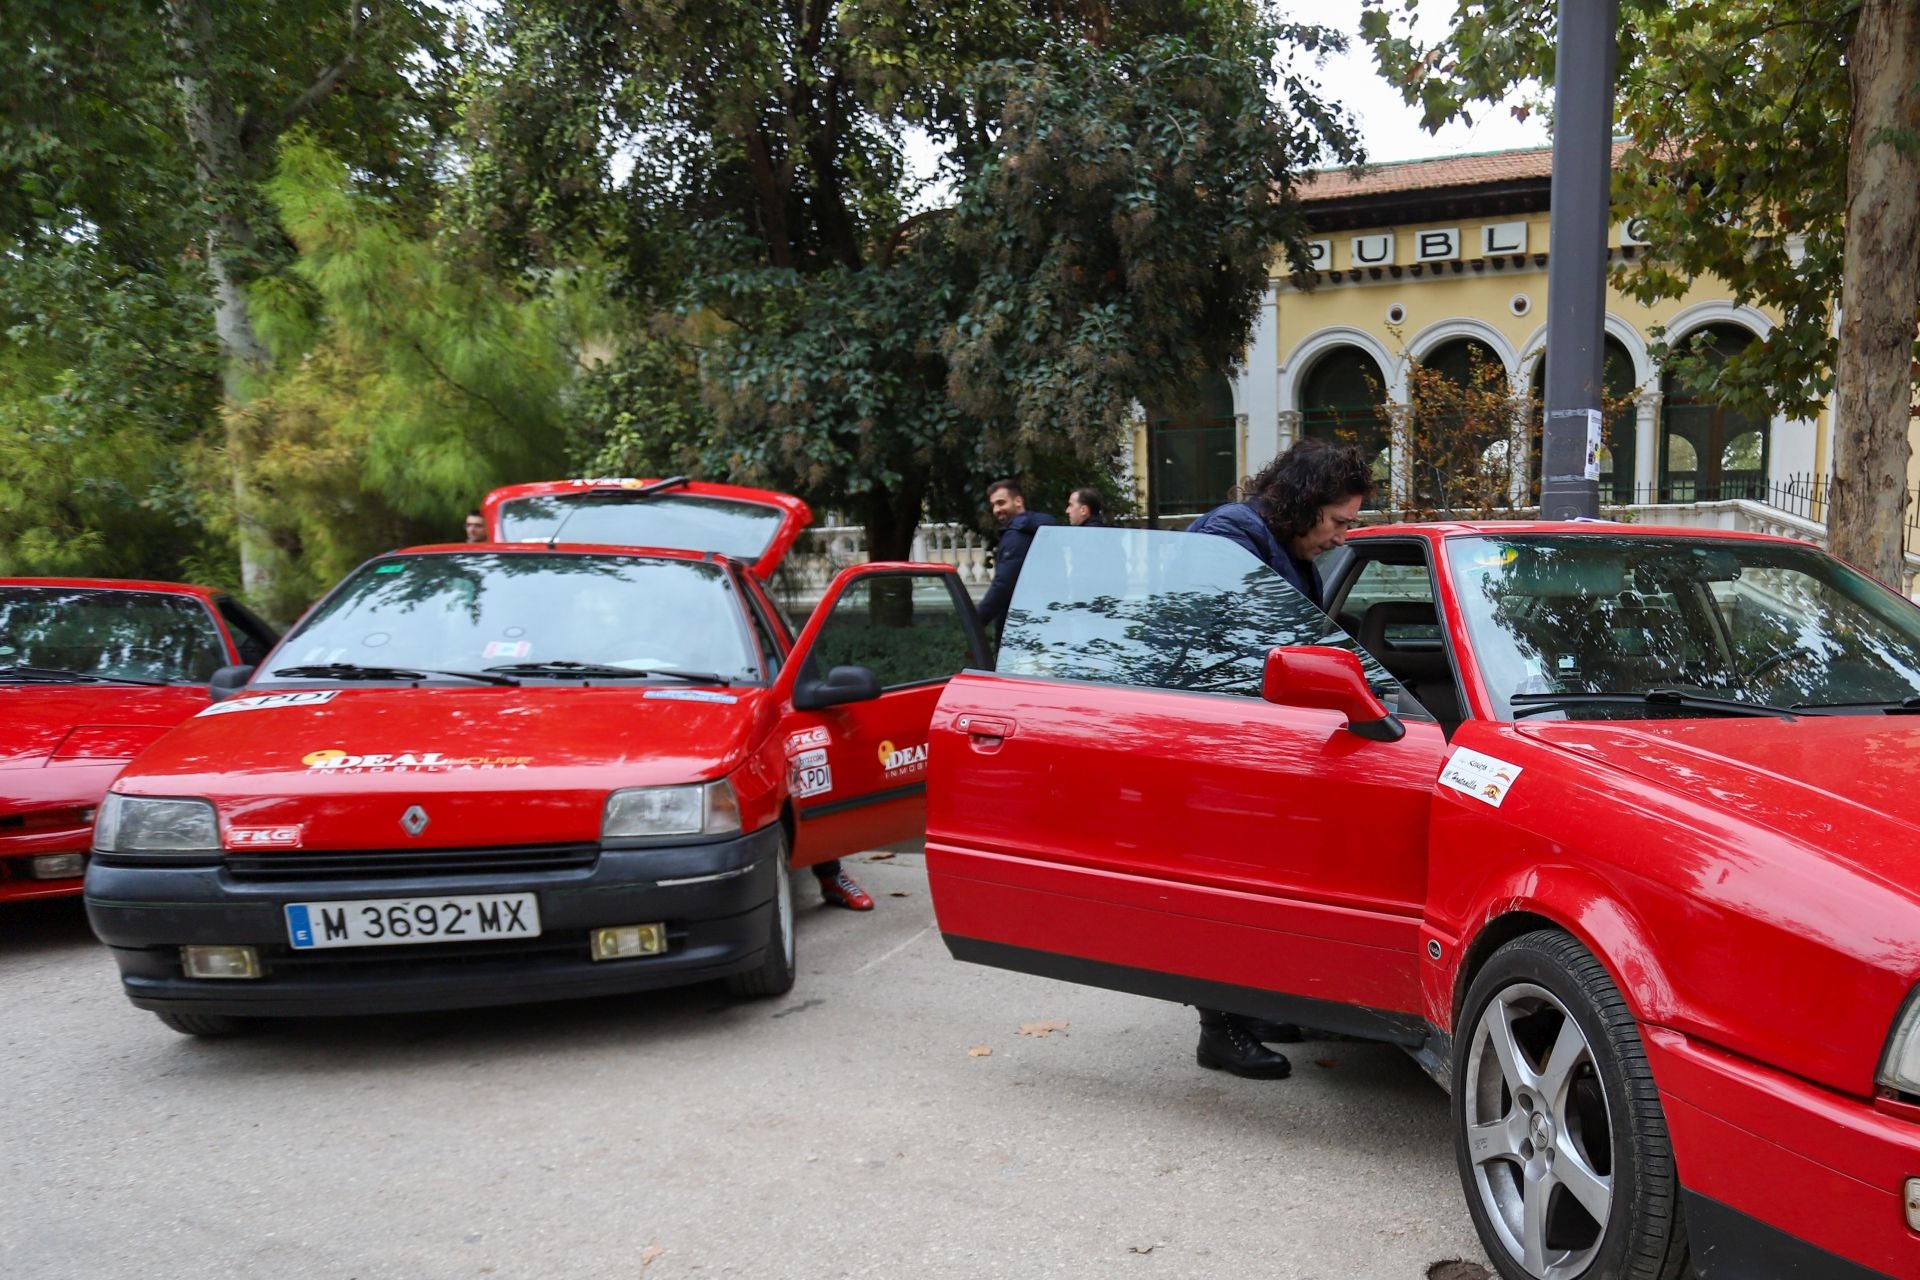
[774,562,989,865]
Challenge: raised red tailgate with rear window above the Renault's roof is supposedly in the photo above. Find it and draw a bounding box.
[482,476,814,581]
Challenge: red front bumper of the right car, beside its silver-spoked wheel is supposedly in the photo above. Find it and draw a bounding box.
[1642,1027,1920,1280]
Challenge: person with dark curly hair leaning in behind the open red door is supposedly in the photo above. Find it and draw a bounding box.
[1188,439,1373,1080]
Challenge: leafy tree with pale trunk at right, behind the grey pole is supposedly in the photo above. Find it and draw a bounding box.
[1361,0,1920,581]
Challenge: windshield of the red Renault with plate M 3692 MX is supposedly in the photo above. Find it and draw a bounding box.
[263,551,760,683]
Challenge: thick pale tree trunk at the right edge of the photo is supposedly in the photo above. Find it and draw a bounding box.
[1828,0,1920,587]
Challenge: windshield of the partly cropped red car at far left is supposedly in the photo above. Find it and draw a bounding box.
[0,587,227,685]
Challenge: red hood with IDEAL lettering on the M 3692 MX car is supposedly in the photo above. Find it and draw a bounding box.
[113,685,764,848]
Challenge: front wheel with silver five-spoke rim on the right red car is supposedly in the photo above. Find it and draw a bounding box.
[1452,929,1688,1280]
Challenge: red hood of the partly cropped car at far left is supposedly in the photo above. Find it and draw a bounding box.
[0,683,207,770]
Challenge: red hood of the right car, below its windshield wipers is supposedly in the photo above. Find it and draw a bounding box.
[1519,716,1920,900]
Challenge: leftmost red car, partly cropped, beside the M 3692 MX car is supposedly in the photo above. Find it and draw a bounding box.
[0,578,276,902]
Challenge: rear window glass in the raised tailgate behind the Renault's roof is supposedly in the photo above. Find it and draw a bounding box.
[499,489,781,564]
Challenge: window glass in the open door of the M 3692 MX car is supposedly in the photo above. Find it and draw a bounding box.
[808,574,973,689]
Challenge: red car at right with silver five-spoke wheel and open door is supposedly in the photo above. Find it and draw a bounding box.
[927,524,1920,1280]
